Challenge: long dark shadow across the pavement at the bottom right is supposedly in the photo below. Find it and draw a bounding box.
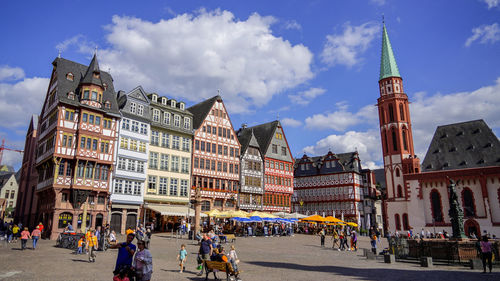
[245,261,500,281]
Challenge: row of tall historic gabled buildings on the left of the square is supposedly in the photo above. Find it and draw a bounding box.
[15,52,294,238]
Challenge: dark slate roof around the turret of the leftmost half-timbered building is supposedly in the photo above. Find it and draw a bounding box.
[52,58,120,117]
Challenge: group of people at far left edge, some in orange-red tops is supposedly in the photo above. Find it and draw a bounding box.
[0,222,44,250]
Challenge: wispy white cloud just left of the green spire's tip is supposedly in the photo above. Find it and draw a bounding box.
[321,22,380,67]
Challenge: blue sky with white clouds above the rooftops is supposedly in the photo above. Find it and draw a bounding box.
[0,0,500,168]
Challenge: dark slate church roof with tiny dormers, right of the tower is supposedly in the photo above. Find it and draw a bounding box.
[422,119,500,172]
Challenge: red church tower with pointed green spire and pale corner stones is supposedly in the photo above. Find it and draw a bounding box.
[377,24,420,201]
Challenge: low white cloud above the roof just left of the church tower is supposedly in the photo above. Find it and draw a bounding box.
[303,130,382,169]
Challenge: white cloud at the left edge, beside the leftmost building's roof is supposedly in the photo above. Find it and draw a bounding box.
[0,73,49,128]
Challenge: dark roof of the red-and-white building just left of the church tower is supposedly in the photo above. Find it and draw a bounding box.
[294,151,361,177]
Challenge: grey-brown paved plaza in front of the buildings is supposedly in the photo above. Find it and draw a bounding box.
[0,234,500,281]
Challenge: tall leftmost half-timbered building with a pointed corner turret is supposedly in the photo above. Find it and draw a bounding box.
[36,54,120,239]
